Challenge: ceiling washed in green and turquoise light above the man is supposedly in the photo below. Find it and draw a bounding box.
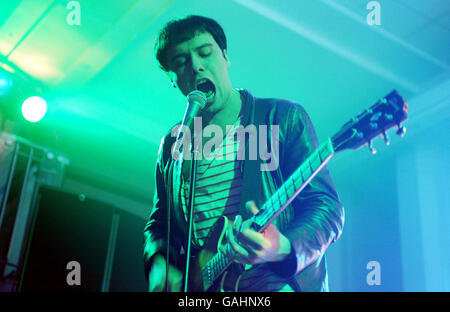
[0,0,450,204]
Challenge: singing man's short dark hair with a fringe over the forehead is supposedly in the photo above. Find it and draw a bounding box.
[155,15,227,72]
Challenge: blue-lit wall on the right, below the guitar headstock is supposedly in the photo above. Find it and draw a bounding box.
[328,80,450,291]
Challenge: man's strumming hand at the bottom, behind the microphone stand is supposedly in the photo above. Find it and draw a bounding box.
[148,254,183,292]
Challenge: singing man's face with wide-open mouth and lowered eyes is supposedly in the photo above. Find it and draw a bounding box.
[168,32,233,113]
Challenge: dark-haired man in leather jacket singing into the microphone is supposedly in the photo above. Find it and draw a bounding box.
[144,16,344,292]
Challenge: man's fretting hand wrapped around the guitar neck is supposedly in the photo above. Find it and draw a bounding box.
[221,201,293,265]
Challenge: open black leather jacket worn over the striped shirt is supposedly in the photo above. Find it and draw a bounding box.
[144,90,344,291]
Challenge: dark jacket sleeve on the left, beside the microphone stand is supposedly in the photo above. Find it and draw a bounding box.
[143,138,179,279]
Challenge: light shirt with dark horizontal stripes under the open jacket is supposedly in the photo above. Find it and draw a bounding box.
[181,119,293,292]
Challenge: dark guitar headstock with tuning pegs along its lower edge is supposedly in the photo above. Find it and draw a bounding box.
[332,90,408,153]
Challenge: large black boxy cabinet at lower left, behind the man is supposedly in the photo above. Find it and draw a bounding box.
[19,187,146,292]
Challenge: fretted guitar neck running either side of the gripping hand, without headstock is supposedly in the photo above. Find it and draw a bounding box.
[203,139,334,288]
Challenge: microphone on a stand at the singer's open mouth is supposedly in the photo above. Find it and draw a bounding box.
[172,90,206,159]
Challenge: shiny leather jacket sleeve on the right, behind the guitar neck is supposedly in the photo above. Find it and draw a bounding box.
[280,104,344,274]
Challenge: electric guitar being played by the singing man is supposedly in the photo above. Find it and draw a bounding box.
[188,90,408,292]
